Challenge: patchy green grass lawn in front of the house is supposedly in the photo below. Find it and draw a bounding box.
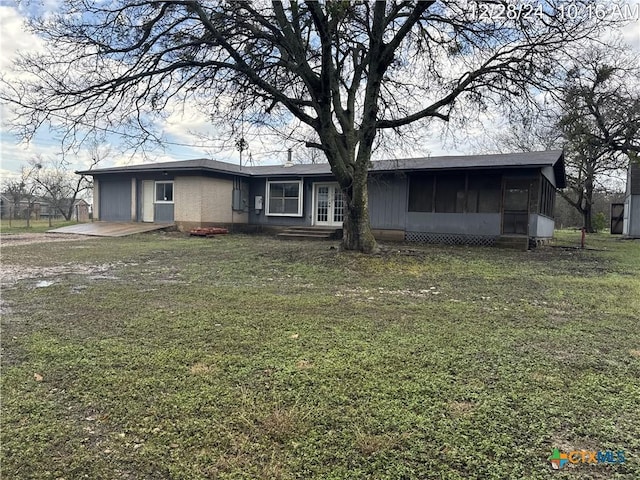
[0,232,640,480]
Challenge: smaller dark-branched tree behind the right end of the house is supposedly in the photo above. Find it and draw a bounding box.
[557,49,640,232]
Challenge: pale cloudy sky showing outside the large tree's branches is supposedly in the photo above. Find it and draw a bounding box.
[0,0,640,179]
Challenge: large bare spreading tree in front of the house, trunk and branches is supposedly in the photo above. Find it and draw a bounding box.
[2,0,613,251]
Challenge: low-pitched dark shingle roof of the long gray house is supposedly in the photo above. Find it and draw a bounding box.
[76,150,565,188]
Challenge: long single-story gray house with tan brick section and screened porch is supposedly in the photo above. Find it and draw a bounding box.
[77,150,565,245]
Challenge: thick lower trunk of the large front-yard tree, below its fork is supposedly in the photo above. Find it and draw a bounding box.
[342,169,378,253]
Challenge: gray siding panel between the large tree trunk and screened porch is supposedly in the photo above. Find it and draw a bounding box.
[368,174,408,230]
